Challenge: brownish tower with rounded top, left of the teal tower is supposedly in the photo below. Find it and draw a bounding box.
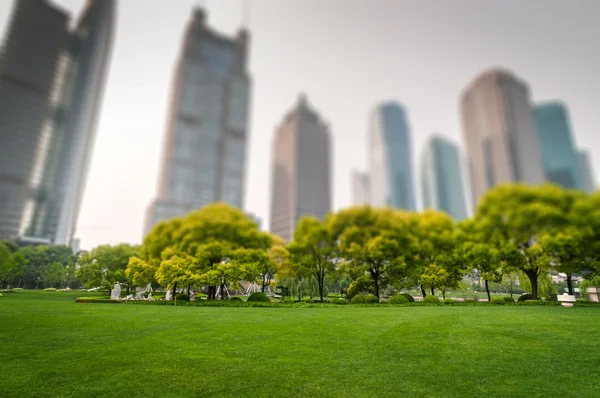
[461,69,545,207]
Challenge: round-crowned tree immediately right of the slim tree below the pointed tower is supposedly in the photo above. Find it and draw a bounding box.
[329,206,410,297]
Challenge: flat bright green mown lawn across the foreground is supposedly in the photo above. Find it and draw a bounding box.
[0,291,600,398]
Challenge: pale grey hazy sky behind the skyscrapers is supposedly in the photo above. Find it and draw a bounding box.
[0,0,600,249]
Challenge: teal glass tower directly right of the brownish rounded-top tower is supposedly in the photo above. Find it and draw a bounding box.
[534,102,583,189]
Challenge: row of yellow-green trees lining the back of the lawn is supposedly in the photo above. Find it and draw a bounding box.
[125,185,600,299]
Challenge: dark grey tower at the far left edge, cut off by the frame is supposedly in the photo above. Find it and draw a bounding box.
[0,0,68,239]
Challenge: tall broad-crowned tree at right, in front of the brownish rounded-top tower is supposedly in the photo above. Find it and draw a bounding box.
[474,184,566,299]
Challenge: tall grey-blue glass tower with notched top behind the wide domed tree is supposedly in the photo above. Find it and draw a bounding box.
[144,9,250,234]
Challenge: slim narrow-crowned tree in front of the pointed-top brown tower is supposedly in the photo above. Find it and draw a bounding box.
[288,217,338,301]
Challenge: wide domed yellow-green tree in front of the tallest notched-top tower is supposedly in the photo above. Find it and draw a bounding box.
[136,203,271,299]
